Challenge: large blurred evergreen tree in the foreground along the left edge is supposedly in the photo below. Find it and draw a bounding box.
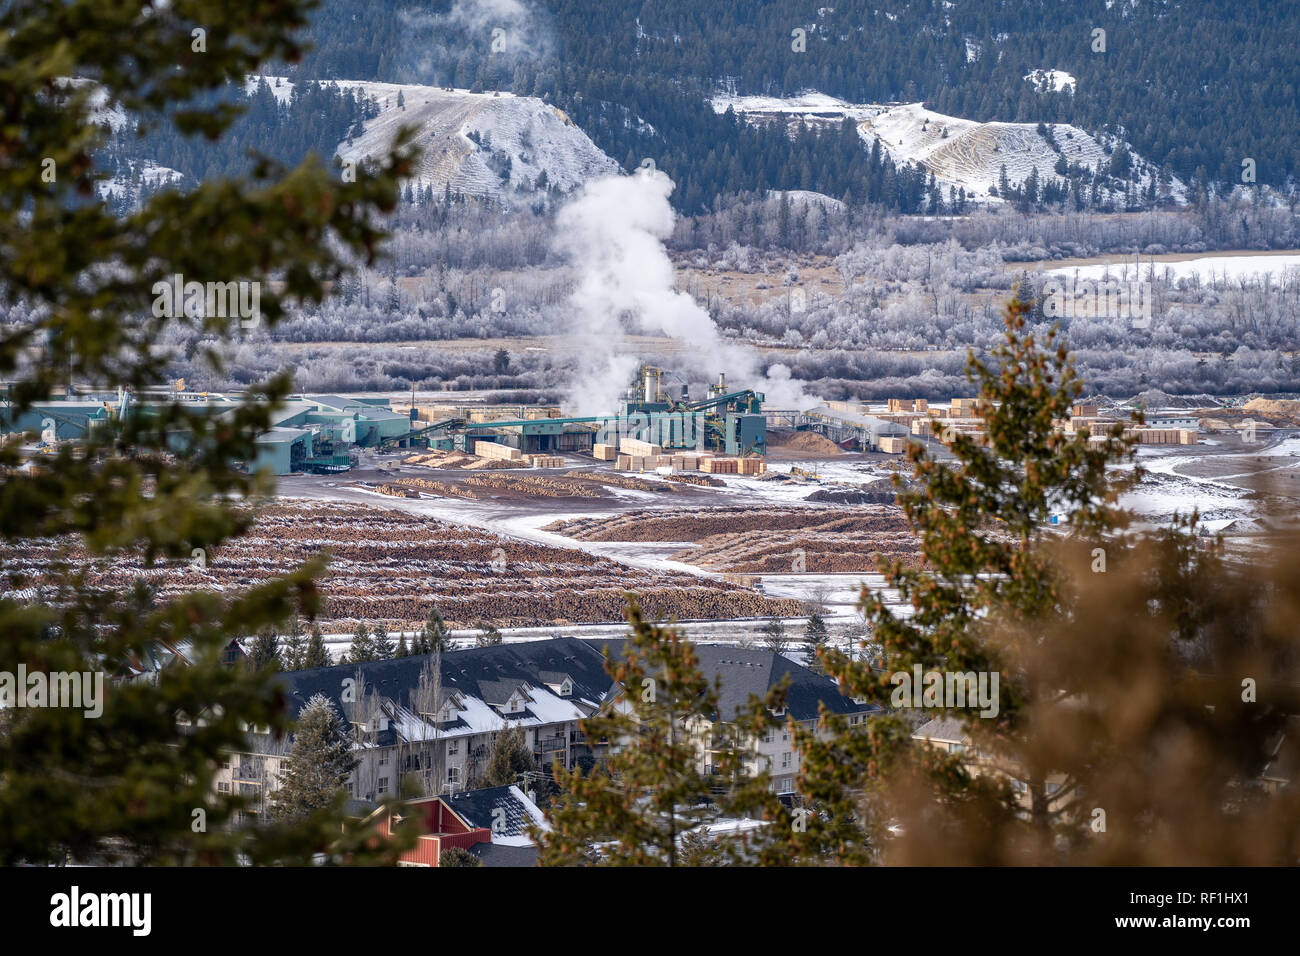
[0,0,410,865]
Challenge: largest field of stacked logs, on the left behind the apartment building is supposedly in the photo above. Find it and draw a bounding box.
[0,501,800,633]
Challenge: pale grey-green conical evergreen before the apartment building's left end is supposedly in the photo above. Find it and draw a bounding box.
[270,693,356,819]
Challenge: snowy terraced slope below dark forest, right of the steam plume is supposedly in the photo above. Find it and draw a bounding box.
[712,92,1186,202]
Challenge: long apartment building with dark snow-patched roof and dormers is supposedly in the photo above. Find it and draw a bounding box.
[216,637,874,816]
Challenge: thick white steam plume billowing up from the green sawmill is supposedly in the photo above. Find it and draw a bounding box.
[556,169,818,415]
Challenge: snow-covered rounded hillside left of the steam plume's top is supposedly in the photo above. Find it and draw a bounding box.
[250,77,619,203]
